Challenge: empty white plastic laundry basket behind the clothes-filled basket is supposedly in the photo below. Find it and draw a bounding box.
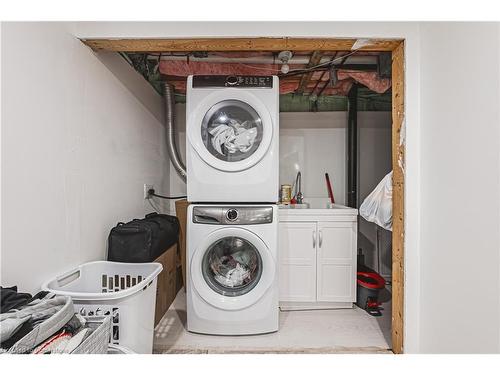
[42,261,163,354]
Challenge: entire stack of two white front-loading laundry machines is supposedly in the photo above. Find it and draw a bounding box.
[186,76,279,335]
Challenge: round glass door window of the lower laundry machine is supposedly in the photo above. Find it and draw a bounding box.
[201,237,262,297]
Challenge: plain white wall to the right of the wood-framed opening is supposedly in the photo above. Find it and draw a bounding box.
[420,23,500,353]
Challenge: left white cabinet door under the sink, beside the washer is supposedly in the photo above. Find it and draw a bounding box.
[279,222,317,302]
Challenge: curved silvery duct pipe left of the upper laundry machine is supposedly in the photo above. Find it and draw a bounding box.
[162,82,187,182]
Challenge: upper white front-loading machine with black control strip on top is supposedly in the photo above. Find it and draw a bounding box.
[186,76,279,203]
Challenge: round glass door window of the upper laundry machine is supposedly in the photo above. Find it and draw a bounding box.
[201,100,264,162]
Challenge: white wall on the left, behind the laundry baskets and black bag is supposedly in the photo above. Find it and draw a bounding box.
[1,23,169,292]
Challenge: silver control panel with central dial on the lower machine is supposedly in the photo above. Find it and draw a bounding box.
[193,206,273,225]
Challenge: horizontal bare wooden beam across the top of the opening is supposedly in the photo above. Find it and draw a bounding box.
[82,37,402,53]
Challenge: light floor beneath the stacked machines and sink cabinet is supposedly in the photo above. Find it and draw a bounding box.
[154,290,391,353]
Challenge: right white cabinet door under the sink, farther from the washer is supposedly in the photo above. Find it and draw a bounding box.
[317,222,357,302]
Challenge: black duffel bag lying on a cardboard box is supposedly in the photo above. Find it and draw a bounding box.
[108,212,179,263]
